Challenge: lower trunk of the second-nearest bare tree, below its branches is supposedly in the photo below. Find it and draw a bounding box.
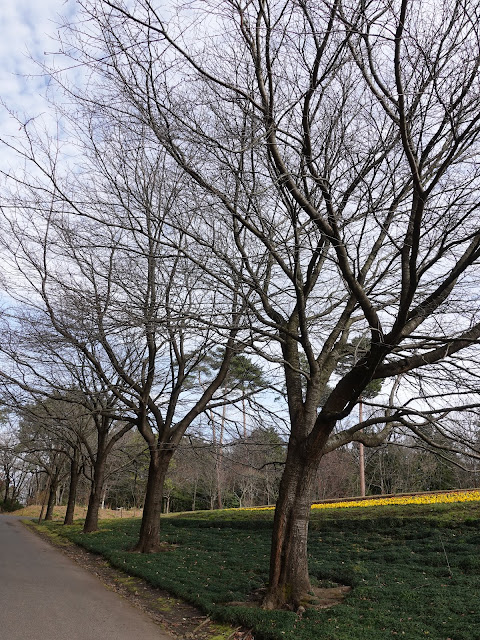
[133,450,173,553]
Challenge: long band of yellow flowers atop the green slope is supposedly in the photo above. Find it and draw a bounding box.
[235,490,480,511]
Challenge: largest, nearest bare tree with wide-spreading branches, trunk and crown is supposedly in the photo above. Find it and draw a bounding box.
[47,0,480,607]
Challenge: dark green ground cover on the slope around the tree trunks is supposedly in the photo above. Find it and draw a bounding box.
[38,502,480,640]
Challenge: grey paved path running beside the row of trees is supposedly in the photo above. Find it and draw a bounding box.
[0,515,173,640]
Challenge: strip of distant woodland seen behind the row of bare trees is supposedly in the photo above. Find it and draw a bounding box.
[0,421,480,524]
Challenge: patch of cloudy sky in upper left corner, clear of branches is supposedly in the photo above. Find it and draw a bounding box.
[0,0,75,165]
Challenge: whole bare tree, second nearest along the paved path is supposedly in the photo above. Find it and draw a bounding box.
[0,96,249,552]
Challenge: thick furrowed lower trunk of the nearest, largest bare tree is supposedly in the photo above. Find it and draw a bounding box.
[263,446,321,609]
